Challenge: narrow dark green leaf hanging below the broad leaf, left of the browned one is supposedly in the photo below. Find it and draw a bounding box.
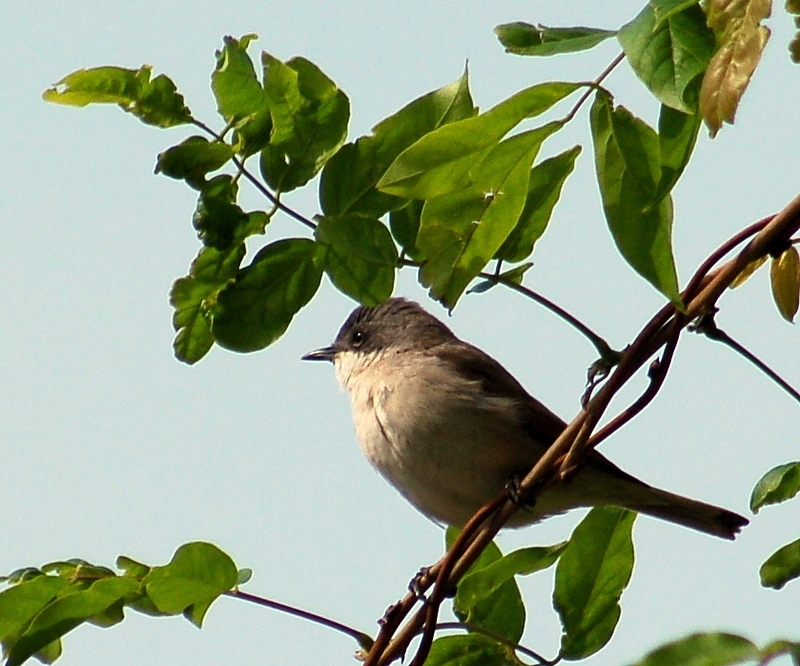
[651,104,703,202]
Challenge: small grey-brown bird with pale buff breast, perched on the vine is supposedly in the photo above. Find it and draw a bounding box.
[303,298,748,539]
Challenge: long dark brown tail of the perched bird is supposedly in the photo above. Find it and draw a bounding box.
[625,483,750,540]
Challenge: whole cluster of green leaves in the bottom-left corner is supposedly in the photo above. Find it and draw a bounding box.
[0,542,241,666]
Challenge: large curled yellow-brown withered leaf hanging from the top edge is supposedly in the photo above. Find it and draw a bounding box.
[700,0,772,137]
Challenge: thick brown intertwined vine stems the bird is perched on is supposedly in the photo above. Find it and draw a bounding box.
[366,191,800,666]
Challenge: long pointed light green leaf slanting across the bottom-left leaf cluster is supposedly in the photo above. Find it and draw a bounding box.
[6,577,139,666]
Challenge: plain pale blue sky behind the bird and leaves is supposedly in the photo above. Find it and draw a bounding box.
[0,0,800,666]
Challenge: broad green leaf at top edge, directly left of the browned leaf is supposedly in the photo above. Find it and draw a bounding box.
[618,4,715,113]
